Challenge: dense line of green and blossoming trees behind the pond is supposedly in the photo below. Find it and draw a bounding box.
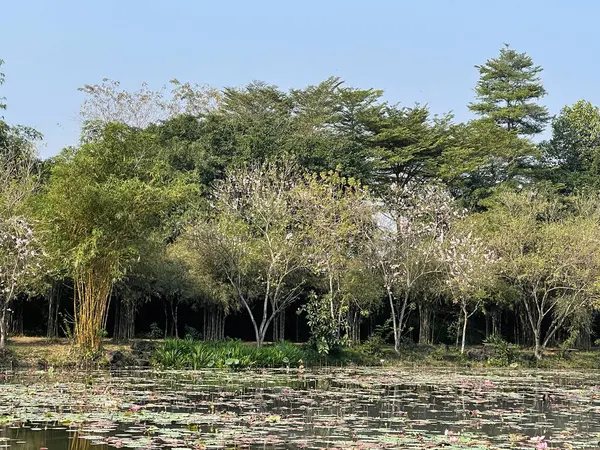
[0,46,600,358]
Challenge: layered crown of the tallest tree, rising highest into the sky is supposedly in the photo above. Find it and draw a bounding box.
[469,45,549,136]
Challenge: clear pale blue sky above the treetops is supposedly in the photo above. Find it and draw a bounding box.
[0,0,600,156]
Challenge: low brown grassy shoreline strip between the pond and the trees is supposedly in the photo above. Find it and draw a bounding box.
[0,337,600,371]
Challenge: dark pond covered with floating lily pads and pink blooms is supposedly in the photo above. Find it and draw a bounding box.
[0,367,600,450]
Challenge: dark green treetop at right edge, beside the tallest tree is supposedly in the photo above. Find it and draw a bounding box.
[541,100,600,191]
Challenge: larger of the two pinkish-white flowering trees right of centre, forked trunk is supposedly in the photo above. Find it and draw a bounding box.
[373,182,463,351]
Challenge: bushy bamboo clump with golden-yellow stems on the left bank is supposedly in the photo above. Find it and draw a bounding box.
[42,124,194,351]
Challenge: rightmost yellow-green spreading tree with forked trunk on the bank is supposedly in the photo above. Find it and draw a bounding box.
[481,190,600,359]
